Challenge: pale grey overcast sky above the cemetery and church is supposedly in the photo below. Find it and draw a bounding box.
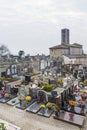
[0,0,87,55]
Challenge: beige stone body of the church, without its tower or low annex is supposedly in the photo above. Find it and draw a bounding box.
[49,43,83,58]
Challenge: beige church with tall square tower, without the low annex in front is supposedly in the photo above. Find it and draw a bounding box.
[49,29,83,58]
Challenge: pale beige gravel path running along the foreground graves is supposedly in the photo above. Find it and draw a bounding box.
[0,103,86,130]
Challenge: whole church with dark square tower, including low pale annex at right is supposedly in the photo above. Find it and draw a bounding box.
[49,28,87,66]
